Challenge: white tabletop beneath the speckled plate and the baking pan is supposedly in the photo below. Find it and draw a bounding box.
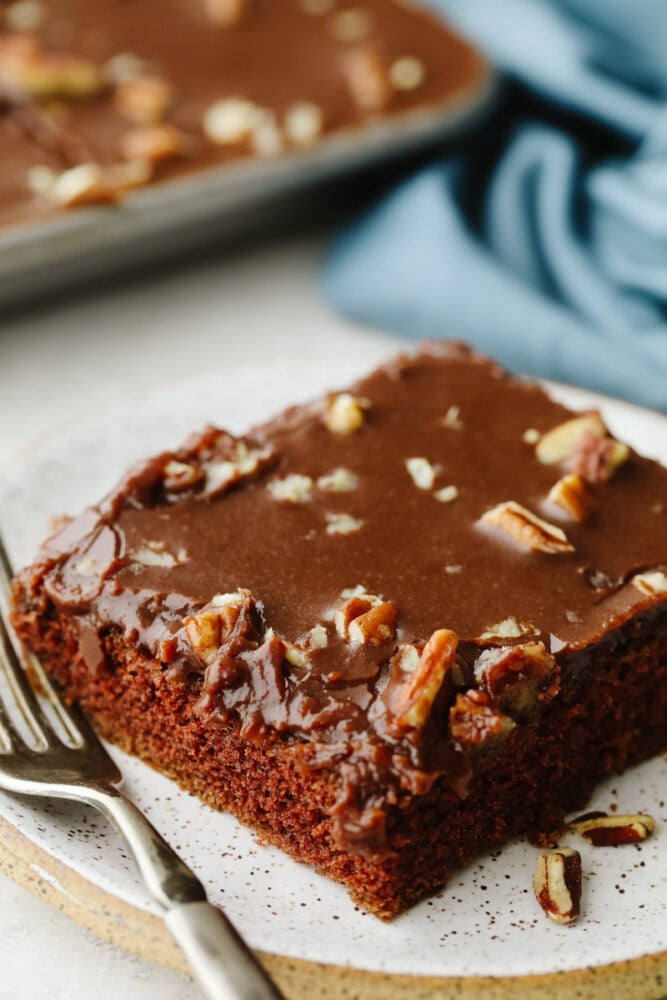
[0,227,396,1000]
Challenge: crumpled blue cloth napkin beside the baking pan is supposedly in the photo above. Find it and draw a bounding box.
[323,0,667,410]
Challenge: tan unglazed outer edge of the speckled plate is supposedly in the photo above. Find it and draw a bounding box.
[0,817,667,1000]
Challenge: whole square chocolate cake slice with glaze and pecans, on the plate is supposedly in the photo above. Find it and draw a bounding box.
[14,344,667,918]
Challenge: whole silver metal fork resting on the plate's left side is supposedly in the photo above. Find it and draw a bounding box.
[0,538,284,1000]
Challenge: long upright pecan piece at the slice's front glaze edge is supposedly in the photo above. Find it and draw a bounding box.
[393,628,458,728]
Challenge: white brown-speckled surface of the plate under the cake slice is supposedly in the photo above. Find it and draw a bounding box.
[0,342,667,995]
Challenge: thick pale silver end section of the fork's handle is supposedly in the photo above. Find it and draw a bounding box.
[164,902,282,1000]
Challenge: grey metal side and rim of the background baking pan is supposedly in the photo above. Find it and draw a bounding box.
[0,66,497,308]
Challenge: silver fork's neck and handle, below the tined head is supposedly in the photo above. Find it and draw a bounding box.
[88,785,284,1000]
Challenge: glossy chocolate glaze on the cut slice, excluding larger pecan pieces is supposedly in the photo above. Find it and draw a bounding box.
[14,345,667,851]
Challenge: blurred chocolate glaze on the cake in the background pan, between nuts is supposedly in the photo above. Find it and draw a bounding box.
[0,0,483,224]
